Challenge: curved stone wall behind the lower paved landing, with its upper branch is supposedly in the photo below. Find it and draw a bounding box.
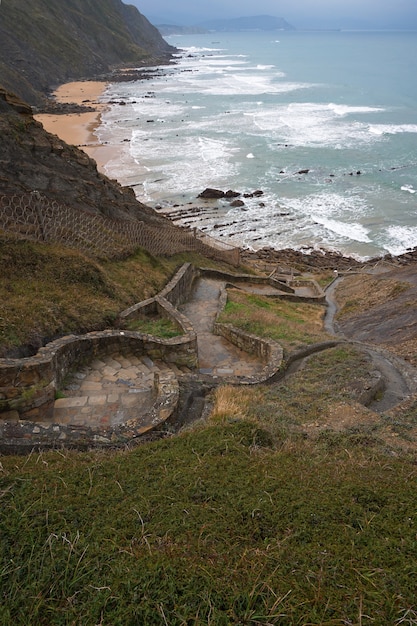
[0,263,198,421]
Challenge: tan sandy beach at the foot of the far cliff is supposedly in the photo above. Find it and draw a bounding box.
[35,81,114,171]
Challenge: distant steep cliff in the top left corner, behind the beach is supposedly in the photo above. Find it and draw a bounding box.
[0,0,174,106]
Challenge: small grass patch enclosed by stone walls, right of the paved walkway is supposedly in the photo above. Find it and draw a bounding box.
[219,289,329,352]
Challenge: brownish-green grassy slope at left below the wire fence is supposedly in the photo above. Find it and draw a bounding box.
[0,234,234,357]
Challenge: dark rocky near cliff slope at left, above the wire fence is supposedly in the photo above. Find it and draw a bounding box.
[0,87,169,225]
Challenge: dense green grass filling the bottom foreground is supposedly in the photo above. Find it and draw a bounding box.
[0,421,417,626]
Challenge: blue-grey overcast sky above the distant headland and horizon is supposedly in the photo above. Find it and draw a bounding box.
[131,0,417,28]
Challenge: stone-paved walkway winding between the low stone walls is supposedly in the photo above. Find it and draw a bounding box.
[54,278,264,429]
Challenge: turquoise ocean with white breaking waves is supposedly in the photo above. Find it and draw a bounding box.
[97,31,417,259]
